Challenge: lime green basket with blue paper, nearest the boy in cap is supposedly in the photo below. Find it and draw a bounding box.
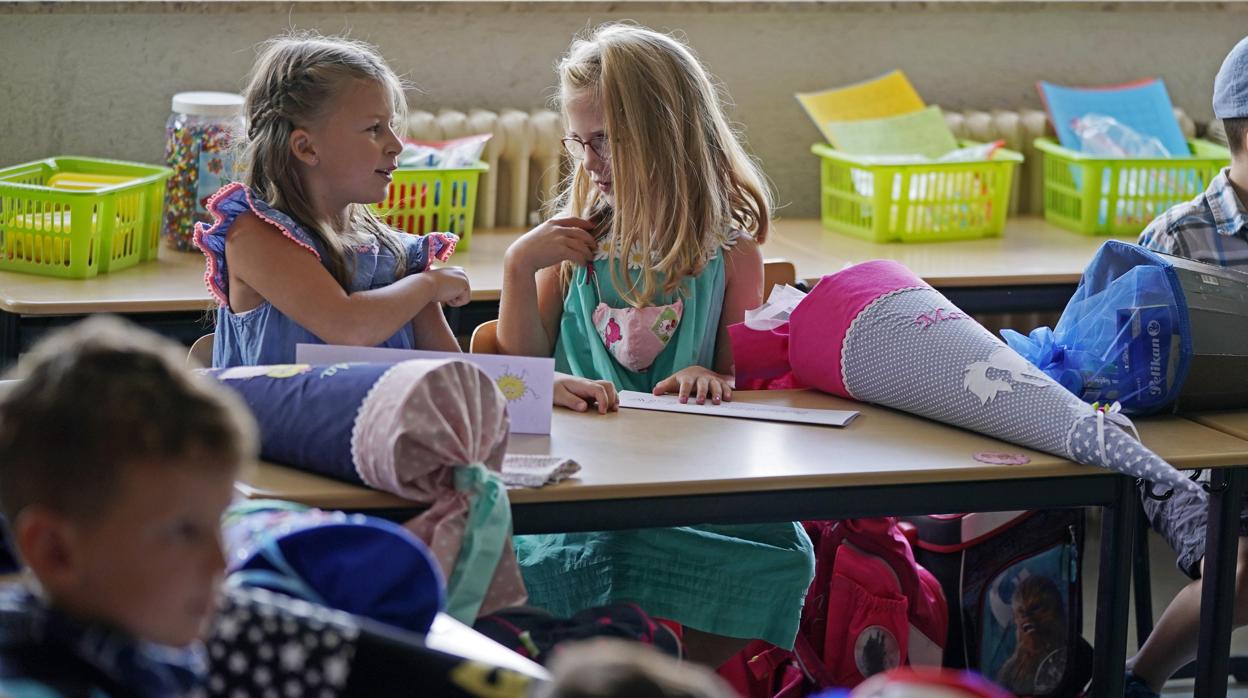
[1035,139,1231,236]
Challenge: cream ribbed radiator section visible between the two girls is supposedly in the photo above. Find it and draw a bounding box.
[407,109,564,227]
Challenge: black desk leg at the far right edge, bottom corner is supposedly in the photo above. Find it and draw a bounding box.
[1194,468,1244,698]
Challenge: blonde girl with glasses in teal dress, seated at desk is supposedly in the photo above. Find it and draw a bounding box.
[498,24,814,666]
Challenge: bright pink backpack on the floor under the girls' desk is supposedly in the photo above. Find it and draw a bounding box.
[719,517,948,698]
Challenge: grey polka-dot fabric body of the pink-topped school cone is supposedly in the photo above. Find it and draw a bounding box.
[828,267,1197,489]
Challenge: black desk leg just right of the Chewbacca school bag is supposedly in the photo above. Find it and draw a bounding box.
[1090,476,1138,697]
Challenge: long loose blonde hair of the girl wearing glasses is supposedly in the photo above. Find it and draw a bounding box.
[557,24,771,307]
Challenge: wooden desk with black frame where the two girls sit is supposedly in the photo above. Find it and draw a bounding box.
[238,391,1248,696]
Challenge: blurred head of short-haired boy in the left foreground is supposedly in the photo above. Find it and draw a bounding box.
[0,318,256,646]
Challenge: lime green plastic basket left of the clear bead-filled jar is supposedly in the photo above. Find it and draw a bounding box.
[0,157,172,278]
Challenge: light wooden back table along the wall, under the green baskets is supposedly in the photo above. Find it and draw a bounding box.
[0,217,1128,367]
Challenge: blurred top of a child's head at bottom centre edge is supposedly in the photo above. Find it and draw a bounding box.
[538,638,736,698]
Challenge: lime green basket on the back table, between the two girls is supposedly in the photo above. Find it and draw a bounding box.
[373,161,489,250]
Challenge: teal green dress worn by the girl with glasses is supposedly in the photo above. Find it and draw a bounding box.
[515,235,815,649]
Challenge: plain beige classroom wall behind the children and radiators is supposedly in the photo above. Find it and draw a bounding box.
[0,0,1248,217]
